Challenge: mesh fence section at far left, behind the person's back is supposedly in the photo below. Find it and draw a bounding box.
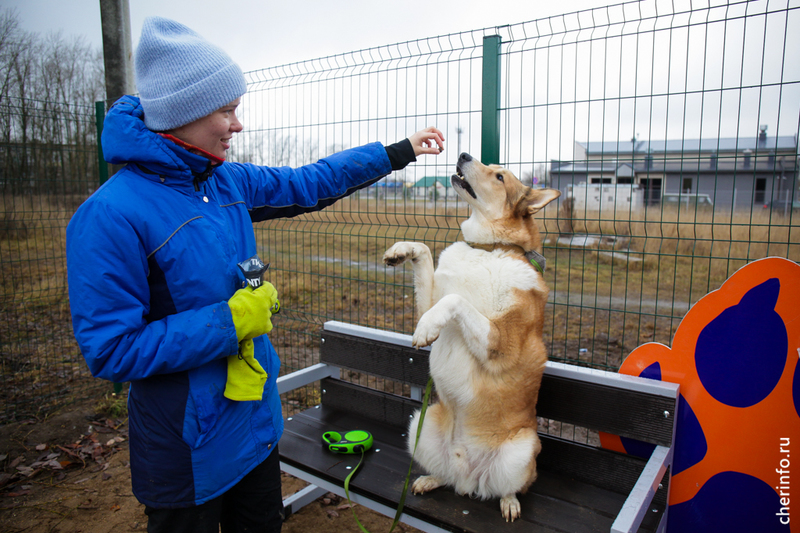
[0,98,105,424]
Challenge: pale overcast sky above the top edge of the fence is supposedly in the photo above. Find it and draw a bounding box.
[6,0,619,72]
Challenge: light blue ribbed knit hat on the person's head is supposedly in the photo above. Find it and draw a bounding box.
[134,17,247,131]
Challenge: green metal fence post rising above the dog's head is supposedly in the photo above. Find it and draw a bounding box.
[481,35,502,165]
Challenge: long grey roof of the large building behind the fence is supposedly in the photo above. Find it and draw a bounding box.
[578,135,797,156]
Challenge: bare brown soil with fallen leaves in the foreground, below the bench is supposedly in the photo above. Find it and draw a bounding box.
[0,403,417,533]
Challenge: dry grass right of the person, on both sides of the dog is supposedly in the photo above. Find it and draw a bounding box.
[260,195,800,369]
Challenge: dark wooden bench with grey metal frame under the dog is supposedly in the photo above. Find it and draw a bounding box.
[278,322,678,533]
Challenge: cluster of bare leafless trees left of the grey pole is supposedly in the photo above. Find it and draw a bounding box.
[0,9,104,194]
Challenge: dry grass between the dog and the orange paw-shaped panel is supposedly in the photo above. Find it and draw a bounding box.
[544,202,800,369]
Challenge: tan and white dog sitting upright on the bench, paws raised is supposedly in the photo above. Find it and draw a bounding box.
[383,153,561,521]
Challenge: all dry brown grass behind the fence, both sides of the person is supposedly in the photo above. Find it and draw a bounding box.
[0,191,800,423]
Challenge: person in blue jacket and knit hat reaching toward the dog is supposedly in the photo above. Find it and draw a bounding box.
[67,18,444,533]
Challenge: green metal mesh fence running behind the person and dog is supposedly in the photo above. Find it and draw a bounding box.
[0,0,800,419]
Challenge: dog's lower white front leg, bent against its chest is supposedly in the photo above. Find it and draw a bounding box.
[412,294,495,361]
